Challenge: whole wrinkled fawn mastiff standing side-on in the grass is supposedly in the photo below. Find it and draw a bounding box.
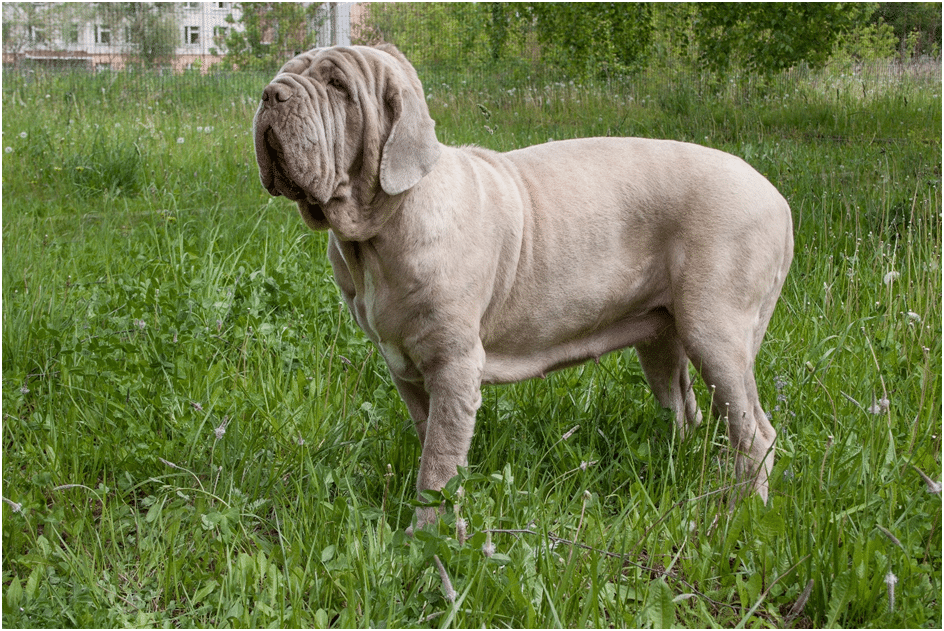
[253,45,793,525]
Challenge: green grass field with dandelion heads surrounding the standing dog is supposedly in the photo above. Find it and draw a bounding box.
[0,63,942,628]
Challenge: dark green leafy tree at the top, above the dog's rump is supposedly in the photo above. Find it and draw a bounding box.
[695,2,875,74]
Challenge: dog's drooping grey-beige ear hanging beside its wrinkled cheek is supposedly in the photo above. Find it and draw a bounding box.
[380,45,439,195]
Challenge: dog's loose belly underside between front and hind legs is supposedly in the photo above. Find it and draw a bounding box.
[482,308,672,383]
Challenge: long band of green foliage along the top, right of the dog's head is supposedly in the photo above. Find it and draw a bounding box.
[360,2,940,80]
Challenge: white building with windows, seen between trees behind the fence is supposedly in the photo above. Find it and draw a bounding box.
[3,2,353,72]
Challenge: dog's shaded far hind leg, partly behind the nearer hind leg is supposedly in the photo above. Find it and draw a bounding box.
[636,324,702,437]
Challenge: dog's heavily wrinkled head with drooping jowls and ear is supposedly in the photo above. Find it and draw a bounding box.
[253,45,439,241]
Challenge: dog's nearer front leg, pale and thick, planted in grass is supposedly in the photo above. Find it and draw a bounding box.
[416,346,485,528]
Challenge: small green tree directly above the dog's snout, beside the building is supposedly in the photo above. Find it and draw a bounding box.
[222,2,323,72]
